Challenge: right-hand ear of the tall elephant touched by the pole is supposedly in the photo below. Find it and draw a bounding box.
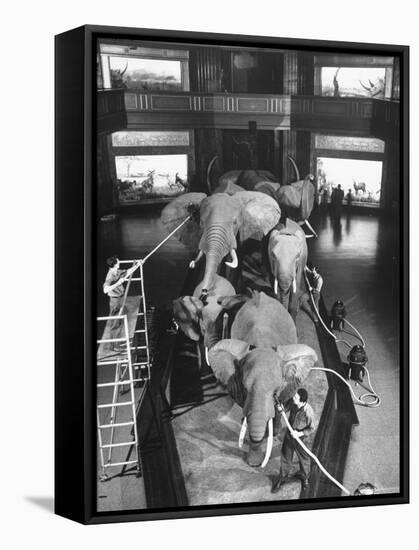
[235,191,281,241]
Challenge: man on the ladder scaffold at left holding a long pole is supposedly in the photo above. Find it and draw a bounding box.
[103,256,138,351]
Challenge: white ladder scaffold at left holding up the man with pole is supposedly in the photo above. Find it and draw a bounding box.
[97,260,151,481]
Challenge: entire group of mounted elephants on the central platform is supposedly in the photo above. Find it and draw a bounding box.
[161,163,317,466]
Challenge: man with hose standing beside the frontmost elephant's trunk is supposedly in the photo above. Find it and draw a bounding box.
[272,388,315,493]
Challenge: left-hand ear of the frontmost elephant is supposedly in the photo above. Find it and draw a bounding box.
[208,338,249,388]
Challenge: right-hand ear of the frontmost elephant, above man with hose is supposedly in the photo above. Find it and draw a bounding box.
[277,344,317,403]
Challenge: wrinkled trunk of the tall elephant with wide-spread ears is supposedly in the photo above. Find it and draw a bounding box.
[199,224,232,294]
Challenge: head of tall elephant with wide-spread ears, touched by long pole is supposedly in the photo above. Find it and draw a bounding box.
[161,191,281,296]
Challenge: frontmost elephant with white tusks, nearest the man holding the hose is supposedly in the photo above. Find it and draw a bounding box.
[208,291,317,466]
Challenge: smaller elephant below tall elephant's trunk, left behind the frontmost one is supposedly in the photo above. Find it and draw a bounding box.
[173,275,236,348]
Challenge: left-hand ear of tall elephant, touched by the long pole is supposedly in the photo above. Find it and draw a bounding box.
[160,193,207,251]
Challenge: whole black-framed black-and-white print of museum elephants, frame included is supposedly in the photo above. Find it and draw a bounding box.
[55,26,408,523]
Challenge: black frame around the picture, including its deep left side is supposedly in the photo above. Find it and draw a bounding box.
[55,25,409,524]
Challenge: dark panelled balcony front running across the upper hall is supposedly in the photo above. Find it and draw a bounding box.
[118,90,399,139]
